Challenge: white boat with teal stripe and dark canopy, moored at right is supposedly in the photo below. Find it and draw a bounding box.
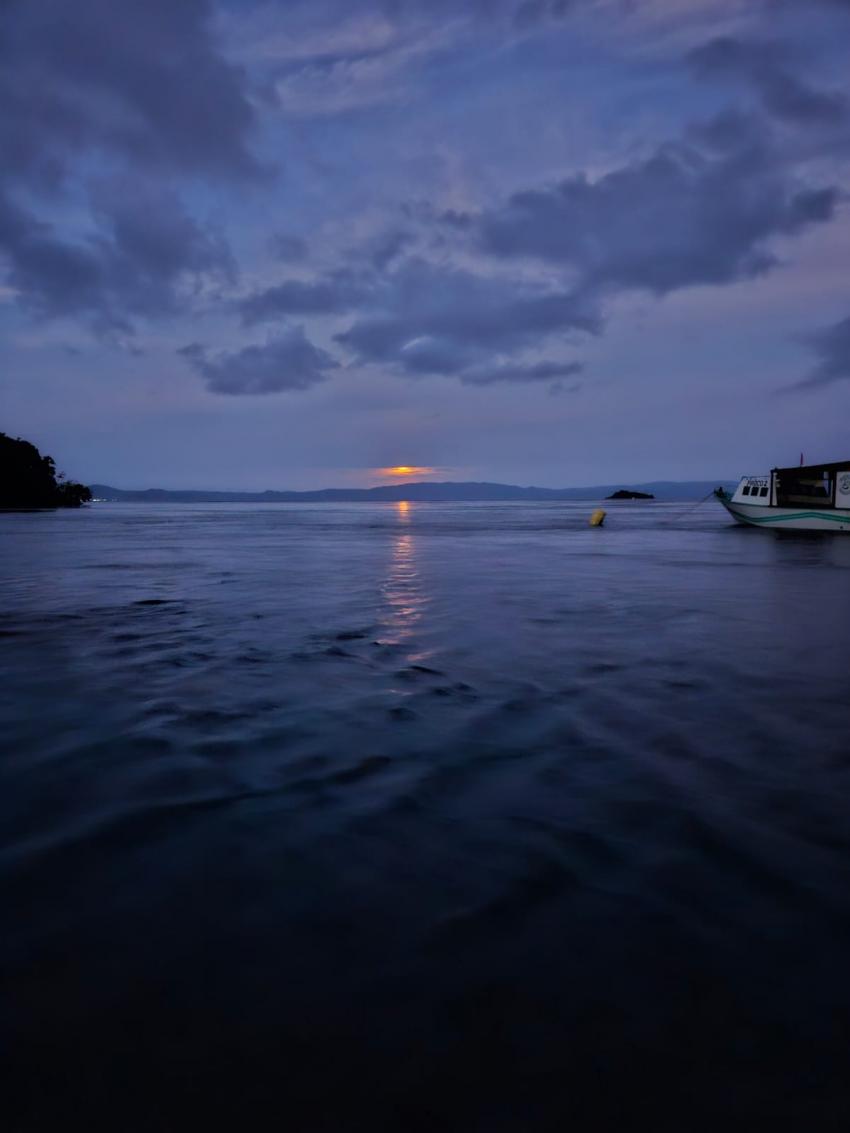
[714,460,850,531]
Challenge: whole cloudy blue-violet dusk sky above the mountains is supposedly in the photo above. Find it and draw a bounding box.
[0,0,850,489]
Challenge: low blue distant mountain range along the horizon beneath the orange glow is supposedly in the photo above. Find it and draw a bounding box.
[90,480,737,503]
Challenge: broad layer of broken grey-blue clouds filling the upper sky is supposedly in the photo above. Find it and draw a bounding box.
[0,0,850,426]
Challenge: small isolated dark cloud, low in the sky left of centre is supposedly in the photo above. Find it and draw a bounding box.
[178,326,339,394]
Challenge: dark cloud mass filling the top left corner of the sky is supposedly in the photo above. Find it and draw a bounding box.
[0,0,260,185]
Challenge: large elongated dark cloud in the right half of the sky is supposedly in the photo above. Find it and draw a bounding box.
[476,144,839,295]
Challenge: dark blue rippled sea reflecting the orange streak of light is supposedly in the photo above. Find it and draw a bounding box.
[0,501,850,1133]
